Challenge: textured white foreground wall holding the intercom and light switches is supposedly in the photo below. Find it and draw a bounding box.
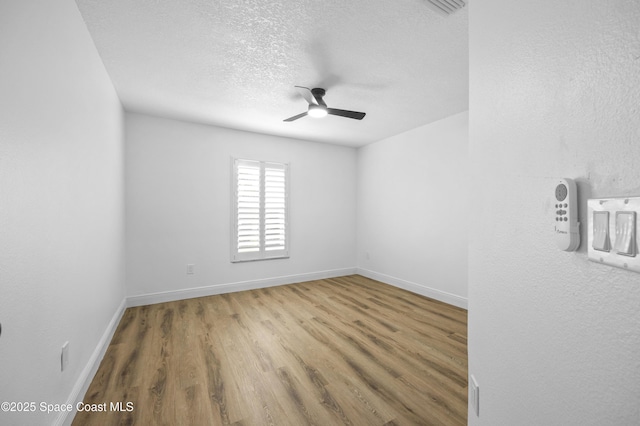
[469,0,640,426]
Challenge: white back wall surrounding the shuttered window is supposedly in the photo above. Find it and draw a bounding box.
[126,113,356,304]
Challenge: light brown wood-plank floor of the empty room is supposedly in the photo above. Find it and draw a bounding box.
[73,275,467,426]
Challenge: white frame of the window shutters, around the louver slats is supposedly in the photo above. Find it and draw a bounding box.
[231,157,291,263]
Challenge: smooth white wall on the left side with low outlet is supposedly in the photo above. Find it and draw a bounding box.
[0,0,125,425]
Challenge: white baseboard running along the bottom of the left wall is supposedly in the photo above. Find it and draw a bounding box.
[53,299,127,426]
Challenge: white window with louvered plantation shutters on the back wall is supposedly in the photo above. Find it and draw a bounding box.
[231,158,289,262]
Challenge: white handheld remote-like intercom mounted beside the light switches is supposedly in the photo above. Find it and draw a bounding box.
[554,179,580,251]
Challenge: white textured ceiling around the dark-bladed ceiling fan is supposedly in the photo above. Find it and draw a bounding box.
[76,0,468,146]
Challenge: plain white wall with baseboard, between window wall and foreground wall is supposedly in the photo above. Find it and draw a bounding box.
[357,112,469,307]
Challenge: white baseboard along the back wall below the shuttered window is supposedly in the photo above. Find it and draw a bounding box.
[127,268,356,307]
